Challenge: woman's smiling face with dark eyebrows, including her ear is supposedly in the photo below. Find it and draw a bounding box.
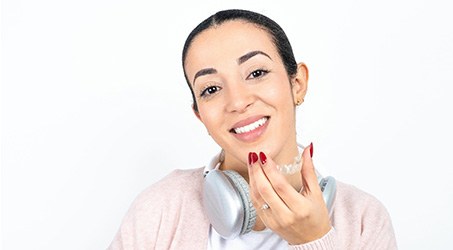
[185,21,306,168]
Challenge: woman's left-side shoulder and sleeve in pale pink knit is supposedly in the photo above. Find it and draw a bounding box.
[109,168,208,249]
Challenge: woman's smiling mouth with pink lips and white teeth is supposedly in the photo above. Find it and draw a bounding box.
[230,116,270,142]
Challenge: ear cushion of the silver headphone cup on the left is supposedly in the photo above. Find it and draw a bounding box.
[223,170,256,234]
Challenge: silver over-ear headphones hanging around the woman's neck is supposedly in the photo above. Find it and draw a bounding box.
[203,147,337,239]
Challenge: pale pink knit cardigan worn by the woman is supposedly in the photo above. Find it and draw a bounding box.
[108,168,397,250]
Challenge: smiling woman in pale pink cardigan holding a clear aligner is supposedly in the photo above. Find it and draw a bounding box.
[110,10,396,249]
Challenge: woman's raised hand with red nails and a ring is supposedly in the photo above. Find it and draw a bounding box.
[249,145,331,245]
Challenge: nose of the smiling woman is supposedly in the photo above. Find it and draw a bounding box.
[226,83,255,113]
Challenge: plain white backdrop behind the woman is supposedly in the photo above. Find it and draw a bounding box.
[1,0,453,250]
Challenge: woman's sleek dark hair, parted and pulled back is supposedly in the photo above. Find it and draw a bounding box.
[182,9,297,112]
